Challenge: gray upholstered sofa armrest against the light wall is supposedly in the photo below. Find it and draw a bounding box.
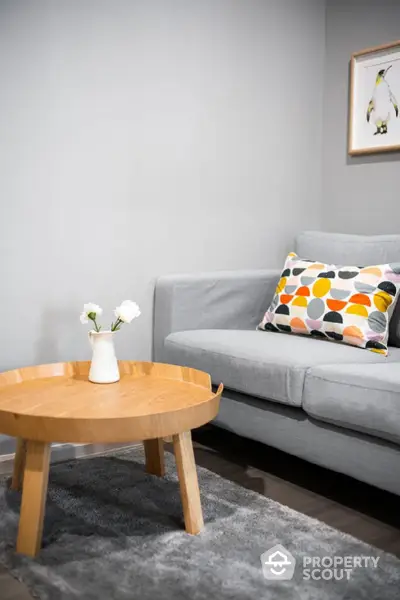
[153,269,280,360]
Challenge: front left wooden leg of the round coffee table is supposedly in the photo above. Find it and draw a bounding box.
[17,440,50,557]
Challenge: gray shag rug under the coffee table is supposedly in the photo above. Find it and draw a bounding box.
[0,447,400,600]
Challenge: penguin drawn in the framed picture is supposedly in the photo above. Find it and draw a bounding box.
[367,65,399,135]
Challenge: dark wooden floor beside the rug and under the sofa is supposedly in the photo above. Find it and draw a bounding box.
[0,426,400,600]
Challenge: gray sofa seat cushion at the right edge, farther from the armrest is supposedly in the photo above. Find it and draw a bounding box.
[303,364,400,442]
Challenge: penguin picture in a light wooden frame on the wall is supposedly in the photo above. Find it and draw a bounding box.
[348,41,400,155]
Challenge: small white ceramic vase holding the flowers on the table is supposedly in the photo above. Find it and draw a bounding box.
[89,331,119,383]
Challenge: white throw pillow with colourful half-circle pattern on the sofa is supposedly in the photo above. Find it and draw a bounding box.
[258,252,400,355]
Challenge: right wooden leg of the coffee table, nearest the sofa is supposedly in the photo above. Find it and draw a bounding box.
[173,431,204,534]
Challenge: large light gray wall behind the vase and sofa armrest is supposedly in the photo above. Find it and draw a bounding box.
[0,0,325,370]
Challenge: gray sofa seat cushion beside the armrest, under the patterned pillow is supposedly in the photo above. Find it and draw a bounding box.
[162,329,400,406]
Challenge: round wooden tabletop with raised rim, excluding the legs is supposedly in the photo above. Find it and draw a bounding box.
[0,361,222,443]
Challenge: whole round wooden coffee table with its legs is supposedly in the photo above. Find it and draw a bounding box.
[0,361,223,556]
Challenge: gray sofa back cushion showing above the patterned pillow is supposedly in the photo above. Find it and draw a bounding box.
[296,231,400,348]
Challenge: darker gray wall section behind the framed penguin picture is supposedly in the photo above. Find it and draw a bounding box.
[322,0,400,234]
